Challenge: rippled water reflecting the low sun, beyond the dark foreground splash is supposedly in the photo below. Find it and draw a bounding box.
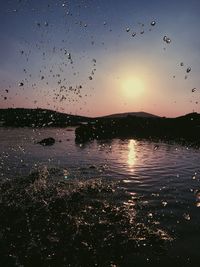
[0,128,200,266]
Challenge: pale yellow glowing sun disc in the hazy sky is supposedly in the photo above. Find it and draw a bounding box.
[121,77,144,98]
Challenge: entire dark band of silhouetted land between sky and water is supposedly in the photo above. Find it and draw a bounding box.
[0,108,200,147]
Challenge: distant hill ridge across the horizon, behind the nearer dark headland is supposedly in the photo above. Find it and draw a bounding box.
[0,108,200,127]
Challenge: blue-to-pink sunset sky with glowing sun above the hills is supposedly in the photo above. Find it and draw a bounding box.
[0,0,200,117]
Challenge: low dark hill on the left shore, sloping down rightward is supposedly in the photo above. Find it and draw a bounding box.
[0,108,89,127]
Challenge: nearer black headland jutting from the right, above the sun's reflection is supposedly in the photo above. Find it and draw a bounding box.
[76,113,200,146]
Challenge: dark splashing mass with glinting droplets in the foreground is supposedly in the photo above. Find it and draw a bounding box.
[0,170,171,267]
